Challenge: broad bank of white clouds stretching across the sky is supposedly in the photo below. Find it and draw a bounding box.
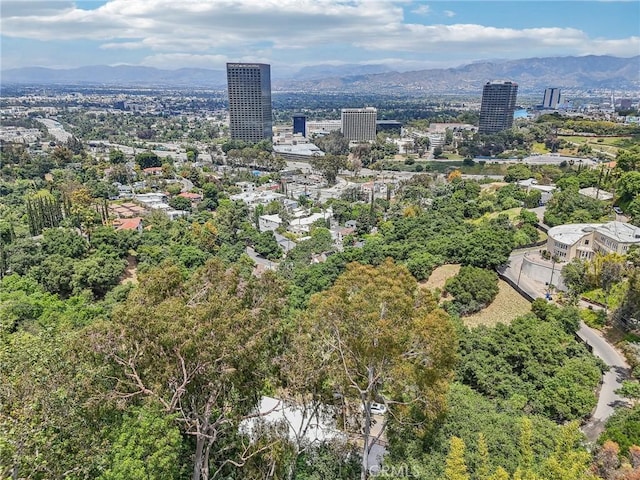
[0,0,640,66]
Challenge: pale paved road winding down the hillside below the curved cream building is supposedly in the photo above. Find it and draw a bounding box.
[499,251,629,441]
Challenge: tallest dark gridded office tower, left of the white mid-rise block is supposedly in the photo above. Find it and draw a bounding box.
[227,63,273,143]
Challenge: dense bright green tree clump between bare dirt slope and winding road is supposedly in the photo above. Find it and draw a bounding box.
[458,308,601,421]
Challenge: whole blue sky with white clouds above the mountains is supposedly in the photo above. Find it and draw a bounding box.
[0,0,640,74]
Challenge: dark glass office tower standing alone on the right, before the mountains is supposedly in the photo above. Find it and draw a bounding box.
[478,81,518,134]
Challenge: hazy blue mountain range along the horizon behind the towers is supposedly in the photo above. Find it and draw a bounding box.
[1,55,640,94]
